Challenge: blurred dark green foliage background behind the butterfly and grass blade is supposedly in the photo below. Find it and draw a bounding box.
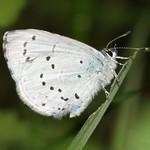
[0,0,150,150]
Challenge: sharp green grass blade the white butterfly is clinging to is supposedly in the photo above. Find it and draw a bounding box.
[68,51,137,150]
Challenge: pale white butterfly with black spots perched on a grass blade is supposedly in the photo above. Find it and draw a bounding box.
[3,29,145,118]
